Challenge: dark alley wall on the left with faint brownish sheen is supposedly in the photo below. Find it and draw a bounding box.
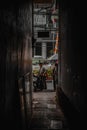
[0,1,32,129]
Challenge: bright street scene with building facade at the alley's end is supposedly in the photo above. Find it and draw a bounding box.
[32,0,59,91]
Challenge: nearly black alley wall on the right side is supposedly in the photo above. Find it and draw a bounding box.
[58,1,86,123]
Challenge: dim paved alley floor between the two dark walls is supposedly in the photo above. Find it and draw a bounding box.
[30,91,69,130]
